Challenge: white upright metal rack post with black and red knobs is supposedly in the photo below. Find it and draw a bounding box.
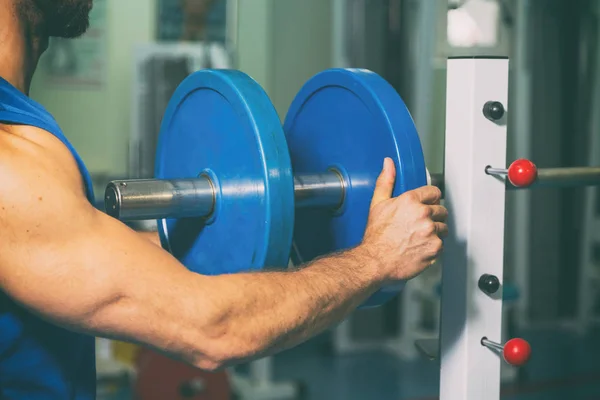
[440,58,508,400]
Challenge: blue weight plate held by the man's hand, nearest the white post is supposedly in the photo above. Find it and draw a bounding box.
[284,69,427,308]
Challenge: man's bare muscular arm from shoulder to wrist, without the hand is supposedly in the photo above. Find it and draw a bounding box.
[0,127,381,369]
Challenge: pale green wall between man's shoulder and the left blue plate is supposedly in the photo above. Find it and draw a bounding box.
[31,0,155,175]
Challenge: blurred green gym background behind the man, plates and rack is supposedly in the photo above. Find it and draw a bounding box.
[32,0,600,400]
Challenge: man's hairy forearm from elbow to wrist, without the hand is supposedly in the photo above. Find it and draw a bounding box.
[190,248,379,364]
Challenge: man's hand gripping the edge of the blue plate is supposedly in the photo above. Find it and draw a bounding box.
[363,159,448,281]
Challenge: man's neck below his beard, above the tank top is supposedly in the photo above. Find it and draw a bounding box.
[0,0,48,95]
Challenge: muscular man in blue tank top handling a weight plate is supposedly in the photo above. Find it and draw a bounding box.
[0,0,447,400]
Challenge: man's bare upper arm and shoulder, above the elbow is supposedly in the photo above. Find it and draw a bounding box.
[0,164,190,330]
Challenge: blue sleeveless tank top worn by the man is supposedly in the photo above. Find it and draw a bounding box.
[0,78,96,400]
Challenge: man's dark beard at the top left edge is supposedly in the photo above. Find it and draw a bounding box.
[25,0,92,39]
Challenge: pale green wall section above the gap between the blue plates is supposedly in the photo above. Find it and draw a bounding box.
[237,0,332,119]
